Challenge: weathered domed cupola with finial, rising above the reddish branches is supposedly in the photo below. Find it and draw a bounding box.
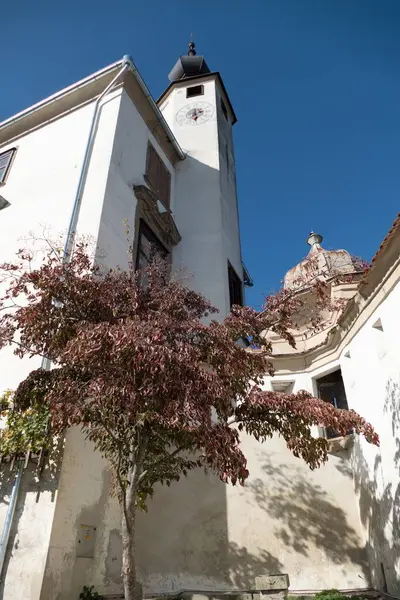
[284,231,359,289]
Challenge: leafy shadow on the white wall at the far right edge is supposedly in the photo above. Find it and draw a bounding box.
[353,379,400,595]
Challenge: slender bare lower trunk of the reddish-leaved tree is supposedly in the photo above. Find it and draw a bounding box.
[121,503,142,600]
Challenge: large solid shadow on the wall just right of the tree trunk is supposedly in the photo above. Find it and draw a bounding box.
[137,470,283,593]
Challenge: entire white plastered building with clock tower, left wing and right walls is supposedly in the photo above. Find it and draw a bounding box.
[0,44,400,600]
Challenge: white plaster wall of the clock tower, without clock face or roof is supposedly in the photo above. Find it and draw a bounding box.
[162,78,242,316]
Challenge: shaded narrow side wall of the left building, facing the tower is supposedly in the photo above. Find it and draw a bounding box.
[40,91,174,600]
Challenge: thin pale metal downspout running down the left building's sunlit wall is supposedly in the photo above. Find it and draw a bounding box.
[0,56,132,581]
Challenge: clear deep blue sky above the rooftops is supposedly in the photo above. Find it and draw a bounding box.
[0,0,400,306]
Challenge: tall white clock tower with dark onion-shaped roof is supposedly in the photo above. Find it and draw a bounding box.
[158,42,244,316]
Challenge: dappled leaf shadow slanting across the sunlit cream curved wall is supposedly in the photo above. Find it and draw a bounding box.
[250,457,369,587]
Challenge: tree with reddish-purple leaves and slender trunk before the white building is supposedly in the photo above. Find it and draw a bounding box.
[0,244,378,600]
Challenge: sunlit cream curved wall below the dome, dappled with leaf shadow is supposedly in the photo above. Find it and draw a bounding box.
[227,363,369,591]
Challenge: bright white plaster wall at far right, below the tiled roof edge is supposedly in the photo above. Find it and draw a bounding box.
[341,283,400,595]
